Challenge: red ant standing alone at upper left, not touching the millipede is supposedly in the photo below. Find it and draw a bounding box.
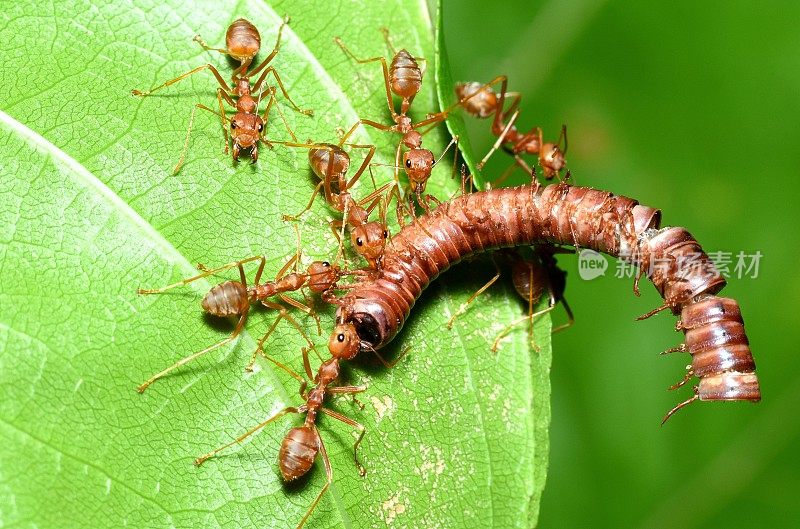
[131,17,313,173]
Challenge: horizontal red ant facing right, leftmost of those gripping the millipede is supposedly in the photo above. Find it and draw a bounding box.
[137,235,355,393]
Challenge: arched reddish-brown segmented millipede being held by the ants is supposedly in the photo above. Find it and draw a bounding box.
[337,183,761,420]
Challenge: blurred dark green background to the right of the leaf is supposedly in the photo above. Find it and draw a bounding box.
[445,0,800,528]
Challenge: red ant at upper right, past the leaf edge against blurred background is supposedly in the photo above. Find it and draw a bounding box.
[455,75,567,180]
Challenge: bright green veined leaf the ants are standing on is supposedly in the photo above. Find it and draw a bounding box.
[0,1,550,527]
